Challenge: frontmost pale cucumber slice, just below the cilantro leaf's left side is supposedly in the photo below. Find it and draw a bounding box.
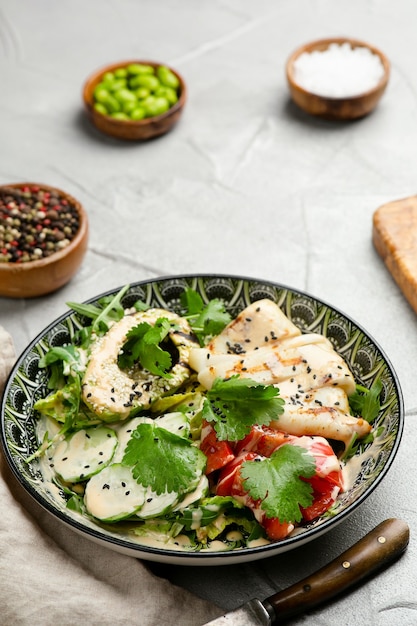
[84,463,147,522]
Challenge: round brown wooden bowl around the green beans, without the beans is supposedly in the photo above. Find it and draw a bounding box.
[83,59,187,141]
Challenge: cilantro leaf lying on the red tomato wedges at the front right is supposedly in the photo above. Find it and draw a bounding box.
[241,444,316,522]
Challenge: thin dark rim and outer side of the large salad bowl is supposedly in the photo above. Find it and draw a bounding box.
[0,273,404,565]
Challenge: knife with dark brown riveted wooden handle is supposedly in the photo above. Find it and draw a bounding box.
[205,518,410,626]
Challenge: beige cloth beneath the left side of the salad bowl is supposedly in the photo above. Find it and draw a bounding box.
[0,327,222,626]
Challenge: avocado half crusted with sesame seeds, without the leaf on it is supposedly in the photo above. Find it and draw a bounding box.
[82,308,198,422]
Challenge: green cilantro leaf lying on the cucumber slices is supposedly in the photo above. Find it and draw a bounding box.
[122,424,206,495]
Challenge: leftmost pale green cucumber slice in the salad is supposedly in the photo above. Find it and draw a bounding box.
[52,426,118,483]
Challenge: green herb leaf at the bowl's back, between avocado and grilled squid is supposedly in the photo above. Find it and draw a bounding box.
[180,288,232,346]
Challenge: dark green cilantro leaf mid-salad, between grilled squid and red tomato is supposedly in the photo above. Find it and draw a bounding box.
[203,375,284,441]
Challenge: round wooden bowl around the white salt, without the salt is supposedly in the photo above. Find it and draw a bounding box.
[286,37,390,120]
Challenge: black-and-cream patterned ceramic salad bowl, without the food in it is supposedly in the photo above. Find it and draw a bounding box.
[1,275,404,566]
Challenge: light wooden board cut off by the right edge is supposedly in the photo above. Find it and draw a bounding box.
[372,196,417,313]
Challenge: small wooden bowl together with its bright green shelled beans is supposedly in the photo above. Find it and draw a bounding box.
[83,60,187,141]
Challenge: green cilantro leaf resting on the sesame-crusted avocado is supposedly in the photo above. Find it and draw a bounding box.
[119,317,172,378]
